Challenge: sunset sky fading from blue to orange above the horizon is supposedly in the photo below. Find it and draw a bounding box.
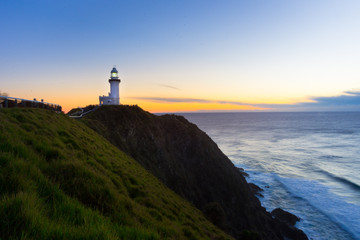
[0,0,360,112]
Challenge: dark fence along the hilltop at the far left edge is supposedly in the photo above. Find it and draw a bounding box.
[0,96,62,112]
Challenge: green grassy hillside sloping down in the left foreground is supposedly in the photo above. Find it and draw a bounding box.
[0,109,230,239]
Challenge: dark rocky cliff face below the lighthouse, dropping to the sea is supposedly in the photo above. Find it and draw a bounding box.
[82,106,306,239]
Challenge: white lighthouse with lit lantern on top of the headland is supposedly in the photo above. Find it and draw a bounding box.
[99,67,121,106]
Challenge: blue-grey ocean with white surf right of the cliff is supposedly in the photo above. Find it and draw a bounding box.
[181,112,360,240]
